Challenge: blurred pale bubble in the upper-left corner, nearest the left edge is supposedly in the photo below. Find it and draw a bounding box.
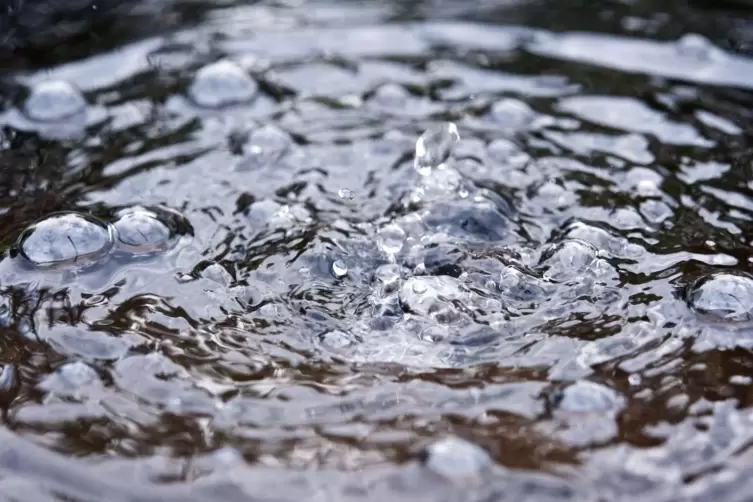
[24,80,87,122]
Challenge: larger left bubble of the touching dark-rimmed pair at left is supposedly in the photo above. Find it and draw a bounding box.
[16,212,114,267]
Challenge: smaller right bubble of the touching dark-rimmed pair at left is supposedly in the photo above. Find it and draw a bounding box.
[113,206,188,253]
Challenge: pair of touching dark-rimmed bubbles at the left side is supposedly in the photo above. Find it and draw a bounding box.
[14,206,193,268]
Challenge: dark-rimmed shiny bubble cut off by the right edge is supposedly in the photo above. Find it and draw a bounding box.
[687,272,753,322]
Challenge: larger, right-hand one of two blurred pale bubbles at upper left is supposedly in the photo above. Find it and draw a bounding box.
[188,59,258,108]
